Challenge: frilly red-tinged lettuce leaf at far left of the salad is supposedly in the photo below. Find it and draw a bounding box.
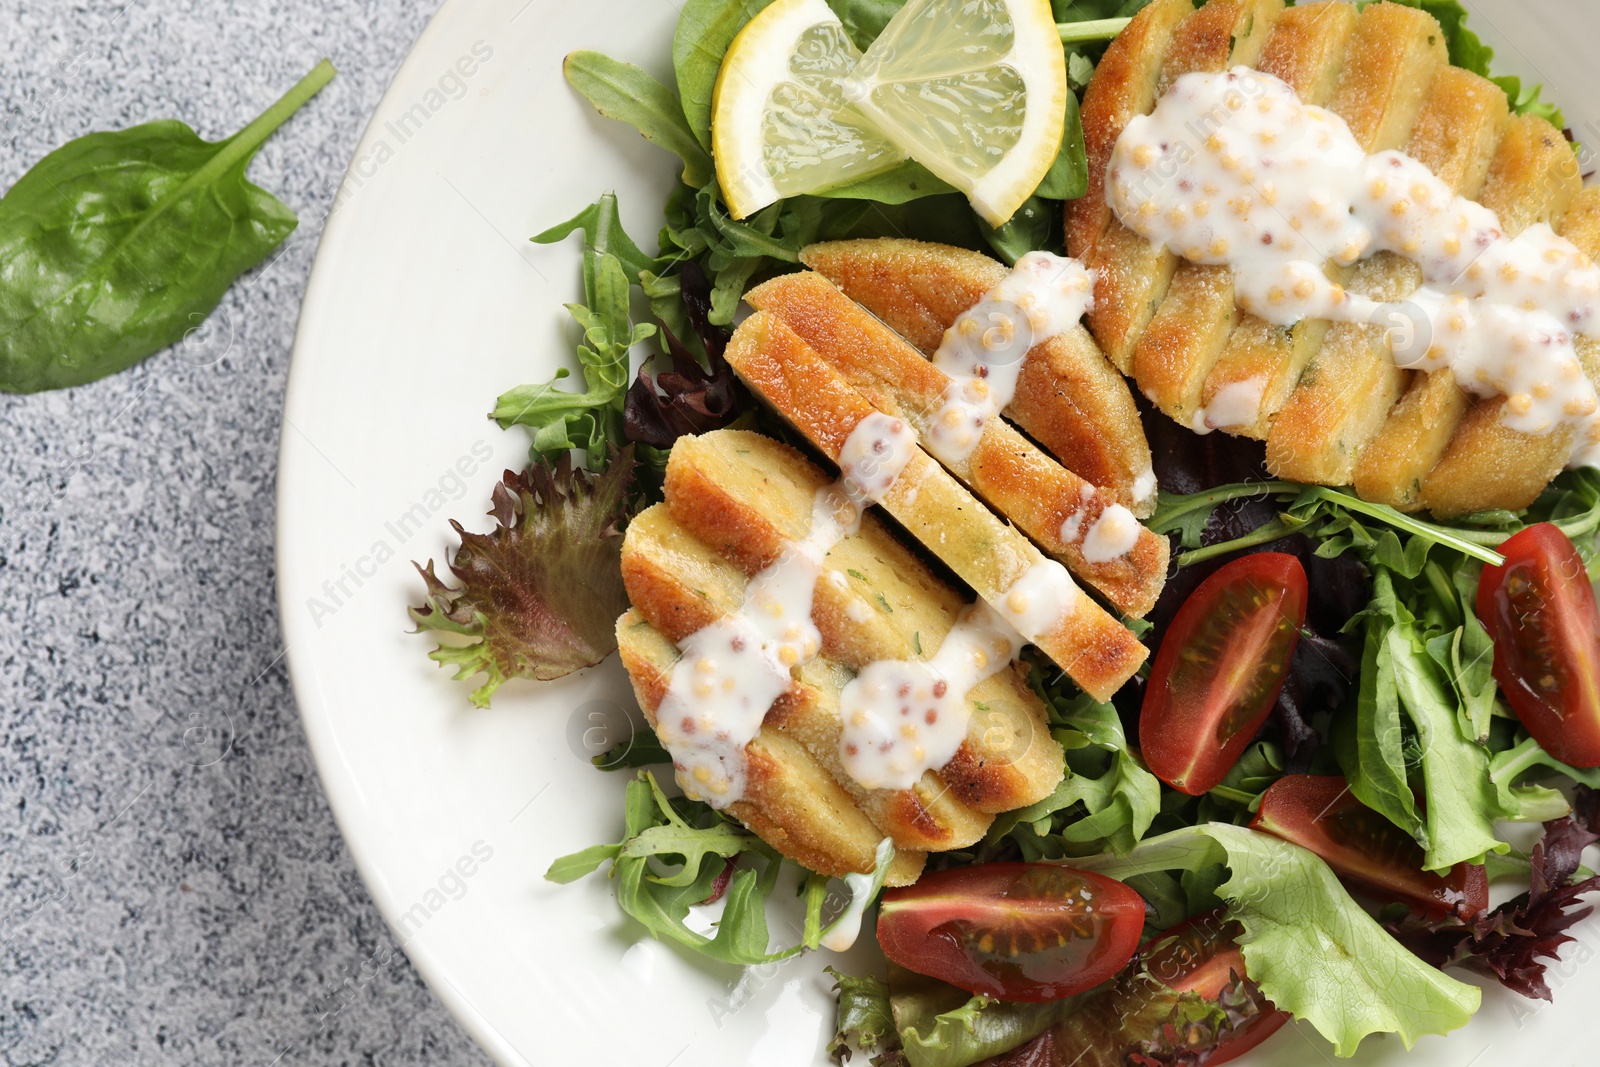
[411,448,634,707]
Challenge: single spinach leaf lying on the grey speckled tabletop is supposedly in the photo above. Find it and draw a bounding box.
[0,59,334,392]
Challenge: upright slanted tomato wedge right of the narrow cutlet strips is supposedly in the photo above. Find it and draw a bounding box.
[1139,552,1307,797]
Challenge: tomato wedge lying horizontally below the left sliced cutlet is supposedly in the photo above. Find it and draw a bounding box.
[878,864,1144,1001]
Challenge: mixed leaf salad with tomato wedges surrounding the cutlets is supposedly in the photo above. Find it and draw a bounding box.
[411,0,1600,1067]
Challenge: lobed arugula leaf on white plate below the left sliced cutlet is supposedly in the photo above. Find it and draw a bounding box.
[544,771,894,965]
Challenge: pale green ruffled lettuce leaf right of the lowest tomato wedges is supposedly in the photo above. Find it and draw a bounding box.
[1074,822,1480,1056]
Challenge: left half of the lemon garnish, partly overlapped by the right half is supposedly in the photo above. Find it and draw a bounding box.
[712,0,906,219]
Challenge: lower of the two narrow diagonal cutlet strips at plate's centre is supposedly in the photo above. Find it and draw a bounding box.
[726,312,1149,701]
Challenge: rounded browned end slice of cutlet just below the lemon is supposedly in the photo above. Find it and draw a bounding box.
[800,238,1155,518]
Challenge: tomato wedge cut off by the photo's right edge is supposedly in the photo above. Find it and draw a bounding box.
[1477,523,1600,768]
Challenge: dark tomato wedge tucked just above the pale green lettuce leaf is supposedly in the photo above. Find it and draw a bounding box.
[1250,774,1490,918]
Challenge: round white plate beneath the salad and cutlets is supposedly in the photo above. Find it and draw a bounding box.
[278,0,1600,1067]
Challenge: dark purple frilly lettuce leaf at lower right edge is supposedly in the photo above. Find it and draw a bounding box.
[1389,785,1600,1000]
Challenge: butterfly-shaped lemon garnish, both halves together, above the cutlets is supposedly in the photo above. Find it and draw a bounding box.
[712,0,1069,226]
